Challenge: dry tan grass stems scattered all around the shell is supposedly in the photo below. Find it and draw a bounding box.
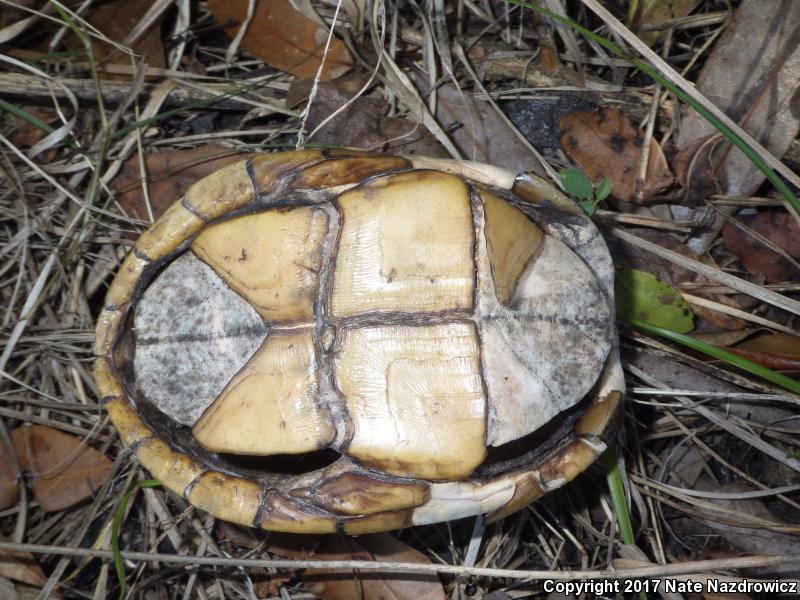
[0,0,800,599]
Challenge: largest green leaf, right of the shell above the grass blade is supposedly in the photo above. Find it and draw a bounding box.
[614,269,694,333]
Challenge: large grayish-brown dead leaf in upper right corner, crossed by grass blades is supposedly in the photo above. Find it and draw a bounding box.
[677,0,800,196]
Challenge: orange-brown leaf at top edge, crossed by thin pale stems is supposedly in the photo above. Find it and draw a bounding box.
[208,0,353,80]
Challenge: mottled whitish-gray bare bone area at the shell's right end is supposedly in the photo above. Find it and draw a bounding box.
[481,236,614,446]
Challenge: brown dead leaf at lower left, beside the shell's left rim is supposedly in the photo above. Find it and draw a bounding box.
[11,425,112,512]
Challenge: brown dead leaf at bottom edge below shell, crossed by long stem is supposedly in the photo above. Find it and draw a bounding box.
[269,533,446,600]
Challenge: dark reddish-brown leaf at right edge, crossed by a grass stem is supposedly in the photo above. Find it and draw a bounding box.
[722,210,800,282]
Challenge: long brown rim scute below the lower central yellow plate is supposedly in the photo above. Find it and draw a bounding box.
[293,472,430,515]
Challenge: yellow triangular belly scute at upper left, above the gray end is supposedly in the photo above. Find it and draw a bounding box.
[192,206,328,324]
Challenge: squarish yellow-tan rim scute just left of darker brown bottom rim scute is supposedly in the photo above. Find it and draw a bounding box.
[187,471,264,527]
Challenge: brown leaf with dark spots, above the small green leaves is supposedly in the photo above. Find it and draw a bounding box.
[560,108,674,202]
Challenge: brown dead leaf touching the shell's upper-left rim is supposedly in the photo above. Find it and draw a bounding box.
[112,144,249,221]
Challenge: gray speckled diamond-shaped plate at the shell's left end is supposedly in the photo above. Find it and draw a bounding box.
[133,251,267,426]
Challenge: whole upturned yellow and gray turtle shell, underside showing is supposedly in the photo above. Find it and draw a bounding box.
[95,151,624,533]
